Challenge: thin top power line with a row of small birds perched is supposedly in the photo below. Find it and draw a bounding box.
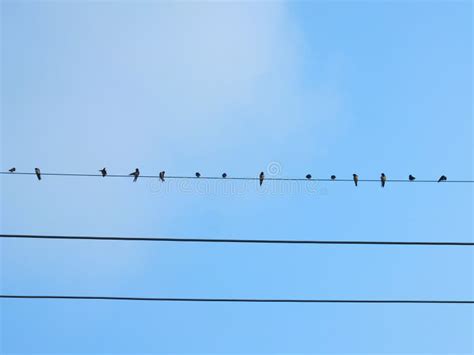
[0,171,474,183]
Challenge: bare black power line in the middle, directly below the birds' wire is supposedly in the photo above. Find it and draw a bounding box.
[0,234,474,246]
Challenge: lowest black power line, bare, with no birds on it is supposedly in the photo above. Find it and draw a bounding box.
[0,295,474,304]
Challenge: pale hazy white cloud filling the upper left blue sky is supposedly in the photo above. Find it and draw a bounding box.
[2,2,343,286]
